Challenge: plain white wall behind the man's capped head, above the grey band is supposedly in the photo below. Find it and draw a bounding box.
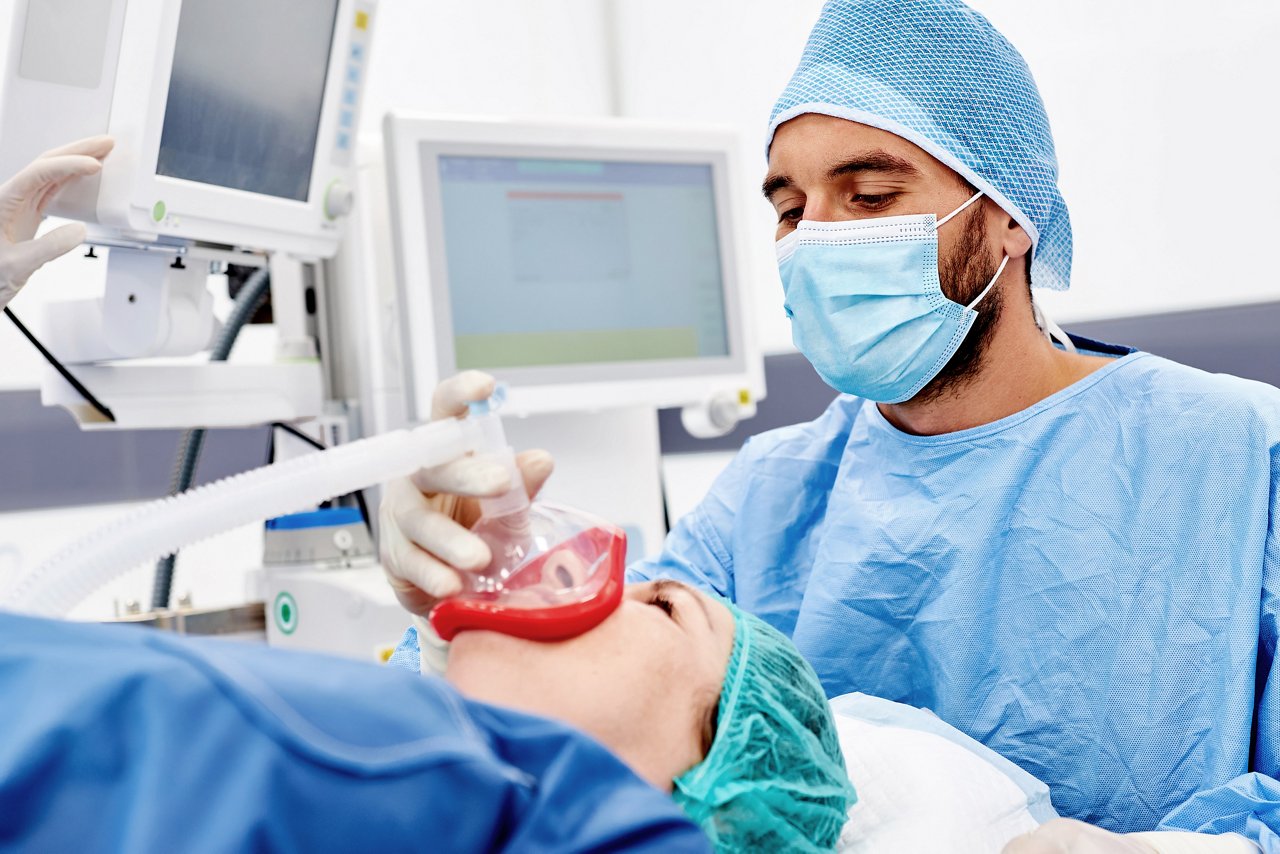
[604,0,1280,352]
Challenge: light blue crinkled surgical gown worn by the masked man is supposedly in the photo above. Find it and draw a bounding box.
[630,339,1280,851]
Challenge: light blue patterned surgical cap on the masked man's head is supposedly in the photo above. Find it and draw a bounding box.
[768,0,1071,291]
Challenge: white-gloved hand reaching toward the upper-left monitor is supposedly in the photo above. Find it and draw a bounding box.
[0,137,115,309]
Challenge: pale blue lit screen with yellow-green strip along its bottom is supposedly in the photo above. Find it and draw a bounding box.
[432,153,728,370]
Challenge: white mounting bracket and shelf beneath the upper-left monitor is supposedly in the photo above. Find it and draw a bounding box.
[41,239,324,429]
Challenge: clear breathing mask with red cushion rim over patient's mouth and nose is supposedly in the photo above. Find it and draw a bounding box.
[429,504,627,641]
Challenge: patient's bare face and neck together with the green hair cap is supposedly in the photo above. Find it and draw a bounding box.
[392,581,854,851]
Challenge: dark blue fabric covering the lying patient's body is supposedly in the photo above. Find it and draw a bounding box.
[0,613,709,854]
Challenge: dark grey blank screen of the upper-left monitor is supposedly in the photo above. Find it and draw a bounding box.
[156,0,338,201]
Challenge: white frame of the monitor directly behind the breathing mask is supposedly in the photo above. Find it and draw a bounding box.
[384,113,763,420]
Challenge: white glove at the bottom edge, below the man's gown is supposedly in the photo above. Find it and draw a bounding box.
[1004,818,1258,854]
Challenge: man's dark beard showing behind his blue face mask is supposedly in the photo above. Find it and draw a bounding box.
[911,205,1005,403]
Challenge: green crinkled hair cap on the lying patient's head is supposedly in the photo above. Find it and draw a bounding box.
[673,602,856,853]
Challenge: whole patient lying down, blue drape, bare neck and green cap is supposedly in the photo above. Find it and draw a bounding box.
[0,583,852,854]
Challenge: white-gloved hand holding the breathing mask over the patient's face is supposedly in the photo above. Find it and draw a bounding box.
[379,371,554,617]
